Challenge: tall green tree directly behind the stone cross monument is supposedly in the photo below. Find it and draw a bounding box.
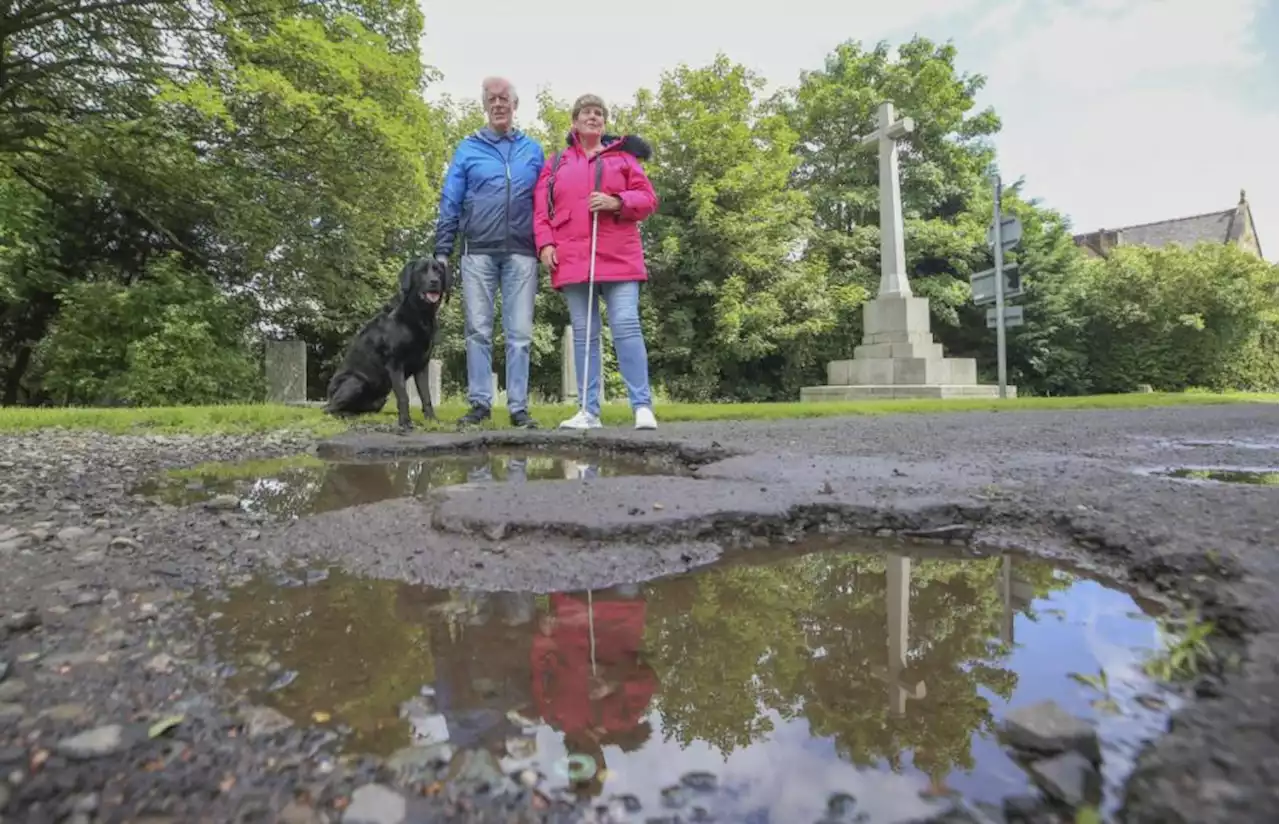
[777,37,1000,360]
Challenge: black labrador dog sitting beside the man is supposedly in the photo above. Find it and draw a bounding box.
[324,258,453,429]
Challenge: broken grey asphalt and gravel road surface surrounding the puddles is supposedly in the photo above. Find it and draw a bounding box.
[0,404,1280,824]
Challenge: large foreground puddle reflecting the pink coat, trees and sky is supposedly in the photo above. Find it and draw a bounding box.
[204,539,1174,824]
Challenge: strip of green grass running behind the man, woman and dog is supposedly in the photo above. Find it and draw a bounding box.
[0,392,1280,435]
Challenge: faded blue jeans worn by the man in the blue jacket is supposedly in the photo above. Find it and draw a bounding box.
[461,255,538,413]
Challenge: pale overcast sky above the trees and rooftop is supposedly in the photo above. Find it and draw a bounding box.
[420,0,1280,261]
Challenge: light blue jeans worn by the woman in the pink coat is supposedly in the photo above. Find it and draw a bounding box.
[562,280,653,415]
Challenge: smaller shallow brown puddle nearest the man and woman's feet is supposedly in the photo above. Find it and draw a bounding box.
[129,450,678,518]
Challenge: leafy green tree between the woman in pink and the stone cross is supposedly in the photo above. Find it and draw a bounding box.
[630,55,849,400]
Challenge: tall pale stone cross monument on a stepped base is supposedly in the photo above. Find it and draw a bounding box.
[800,101,1016,402]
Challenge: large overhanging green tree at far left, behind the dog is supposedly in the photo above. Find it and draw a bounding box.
[0,0,455,403]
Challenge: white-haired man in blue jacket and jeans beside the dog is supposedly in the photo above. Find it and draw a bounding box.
[435,77,545,429]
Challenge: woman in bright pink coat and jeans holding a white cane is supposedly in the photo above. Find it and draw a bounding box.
[534,95,658,429]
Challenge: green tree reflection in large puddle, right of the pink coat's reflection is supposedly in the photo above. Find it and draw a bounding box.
[646,554,1066,775]
